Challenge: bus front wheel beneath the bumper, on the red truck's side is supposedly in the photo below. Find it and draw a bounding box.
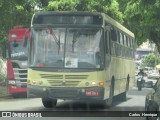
[42,98,57,108]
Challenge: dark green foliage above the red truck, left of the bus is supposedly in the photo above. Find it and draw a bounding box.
[0,0,33,53]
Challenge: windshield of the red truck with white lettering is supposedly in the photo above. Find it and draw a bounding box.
[9,41,28,61]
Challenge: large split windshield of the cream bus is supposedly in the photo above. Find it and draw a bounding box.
[31,27,104,68]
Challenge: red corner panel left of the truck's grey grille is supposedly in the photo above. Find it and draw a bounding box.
[7,60,14,80]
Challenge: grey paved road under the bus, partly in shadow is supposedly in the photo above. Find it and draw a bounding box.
[0,88,150,111]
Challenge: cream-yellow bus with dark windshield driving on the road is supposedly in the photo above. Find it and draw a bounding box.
[27,11,135,108]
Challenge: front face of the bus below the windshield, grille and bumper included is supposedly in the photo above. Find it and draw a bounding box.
[28,69,104,100]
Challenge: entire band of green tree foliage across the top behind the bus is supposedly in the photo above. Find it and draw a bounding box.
[0,0,160,52]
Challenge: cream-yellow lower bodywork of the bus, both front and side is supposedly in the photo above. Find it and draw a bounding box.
[28,57,135,100]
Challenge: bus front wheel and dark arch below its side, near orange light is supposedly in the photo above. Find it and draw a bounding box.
[104,80,114,108]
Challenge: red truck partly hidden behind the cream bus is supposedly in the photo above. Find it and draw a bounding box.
[7,26,30,97]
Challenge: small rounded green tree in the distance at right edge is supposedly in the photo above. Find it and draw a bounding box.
[142,53,160,67]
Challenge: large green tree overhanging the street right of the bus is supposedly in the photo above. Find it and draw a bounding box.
[119,0,160,52]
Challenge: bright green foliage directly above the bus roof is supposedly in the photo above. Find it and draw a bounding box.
[42,0,123,23]
